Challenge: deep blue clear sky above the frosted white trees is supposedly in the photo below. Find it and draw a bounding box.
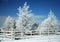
[0,0,60,19]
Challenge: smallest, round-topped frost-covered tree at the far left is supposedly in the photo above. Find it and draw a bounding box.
[3,16,15,30]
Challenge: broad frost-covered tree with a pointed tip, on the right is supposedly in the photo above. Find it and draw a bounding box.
[40,10,58,32]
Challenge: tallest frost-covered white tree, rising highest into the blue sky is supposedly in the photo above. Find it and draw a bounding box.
[16,2,32,35]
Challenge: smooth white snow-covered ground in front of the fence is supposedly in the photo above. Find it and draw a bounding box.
[1,35,60,42]
